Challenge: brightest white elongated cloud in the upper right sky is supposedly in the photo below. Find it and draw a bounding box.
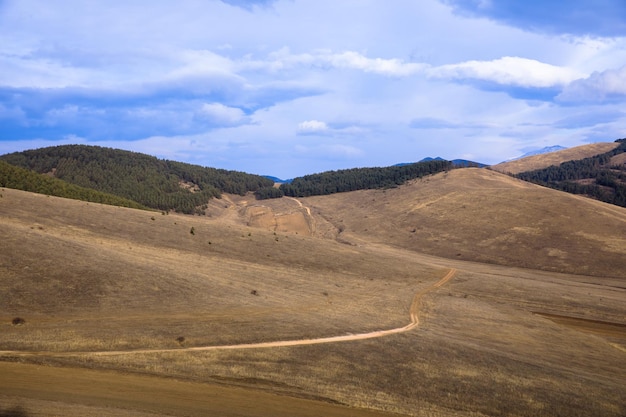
[428,56,584,88]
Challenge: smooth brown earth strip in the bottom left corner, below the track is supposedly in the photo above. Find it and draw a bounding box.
[0,362,393,417]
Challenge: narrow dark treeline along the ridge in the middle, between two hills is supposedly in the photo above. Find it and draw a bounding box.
[257,160,453,198]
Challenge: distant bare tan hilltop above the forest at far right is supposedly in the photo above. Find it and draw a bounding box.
[491,142,619,174]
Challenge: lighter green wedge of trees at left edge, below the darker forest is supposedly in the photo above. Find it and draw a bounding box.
[0,161,146,209]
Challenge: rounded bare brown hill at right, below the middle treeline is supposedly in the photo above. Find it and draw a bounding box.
[234,168,626,278]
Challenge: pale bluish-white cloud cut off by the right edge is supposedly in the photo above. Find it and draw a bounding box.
[557,66,626,103]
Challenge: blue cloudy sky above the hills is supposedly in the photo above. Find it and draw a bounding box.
[0,0,626,178]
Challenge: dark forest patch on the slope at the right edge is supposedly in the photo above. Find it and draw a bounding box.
[516,139,626,207]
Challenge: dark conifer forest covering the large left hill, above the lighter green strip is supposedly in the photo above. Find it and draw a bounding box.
[0,145,273,214]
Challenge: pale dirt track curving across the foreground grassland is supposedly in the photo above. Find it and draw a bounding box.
[0,268,457,356]
